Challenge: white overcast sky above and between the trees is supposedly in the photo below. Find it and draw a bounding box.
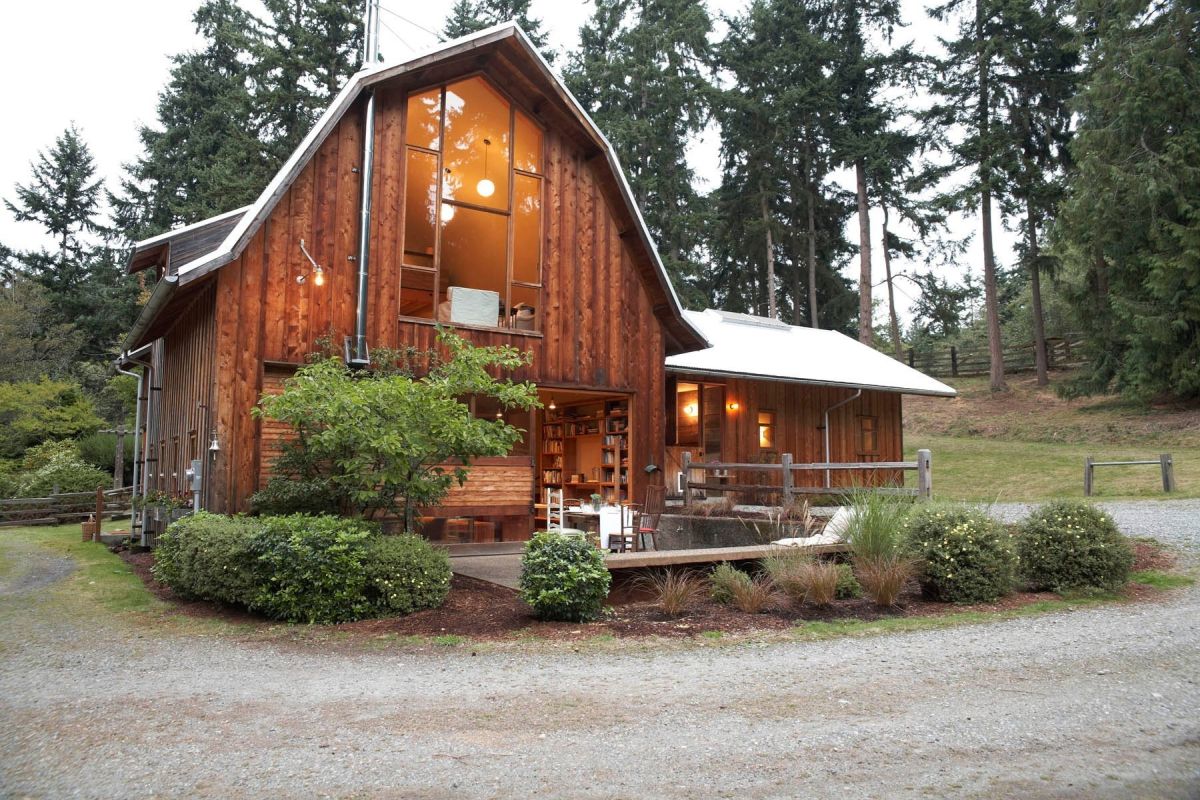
[0,0,1012,320]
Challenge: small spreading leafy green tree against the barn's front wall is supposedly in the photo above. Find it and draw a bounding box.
[256,330,538,531]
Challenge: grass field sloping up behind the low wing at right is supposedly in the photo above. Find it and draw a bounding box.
[905,377,1200,501]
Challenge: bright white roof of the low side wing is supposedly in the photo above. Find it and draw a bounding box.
[666,308,958,397]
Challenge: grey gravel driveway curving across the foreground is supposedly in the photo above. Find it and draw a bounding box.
[0,501,1200,800]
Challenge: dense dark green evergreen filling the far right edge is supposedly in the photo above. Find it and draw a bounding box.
[1056,0,1200,398]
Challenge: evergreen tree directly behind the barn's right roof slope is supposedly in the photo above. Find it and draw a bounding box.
[565,0,712,302]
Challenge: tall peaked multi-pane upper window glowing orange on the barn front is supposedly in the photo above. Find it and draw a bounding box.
[400,76,544,330]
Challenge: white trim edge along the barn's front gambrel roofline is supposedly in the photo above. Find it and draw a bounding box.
[175,20,708,343]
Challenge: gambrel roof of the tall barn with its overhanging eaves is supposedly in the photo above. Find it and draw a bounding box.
[130,22,708,351]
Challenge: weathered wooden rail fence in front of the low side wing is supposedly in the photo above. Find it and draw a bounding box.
[682,450,934,500]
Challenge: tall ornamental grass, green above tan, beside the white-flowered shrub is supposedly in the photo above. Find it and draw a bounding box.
[846,492,916,607]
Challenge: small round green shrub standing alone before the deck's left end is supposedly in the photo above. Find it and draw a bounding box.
[520,533,612,622]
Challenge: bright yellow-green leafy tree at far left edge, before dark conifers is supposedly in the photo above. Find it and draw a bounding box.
[0,378,103,458]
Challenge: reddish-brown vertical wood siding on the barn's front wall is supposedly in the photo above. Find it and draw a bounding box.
[211,85,666,511]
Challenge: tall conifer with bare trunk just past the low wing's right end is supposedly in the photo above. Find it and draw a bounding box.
[926,0,1010,391]
